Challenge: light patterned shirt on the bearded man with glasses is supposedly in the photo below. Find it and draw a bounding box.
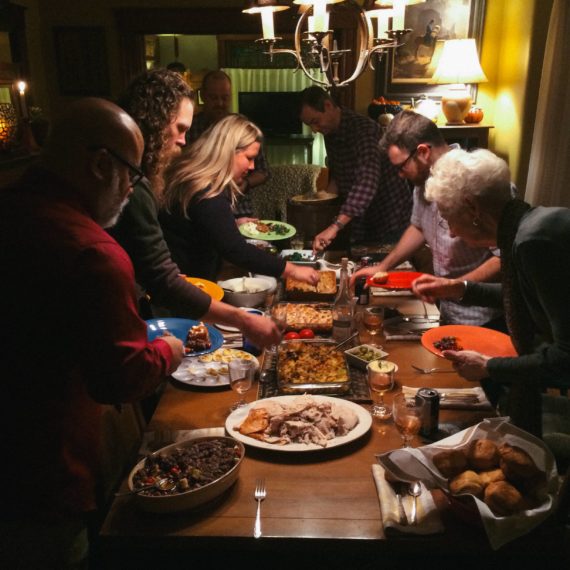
[411,186,502,326]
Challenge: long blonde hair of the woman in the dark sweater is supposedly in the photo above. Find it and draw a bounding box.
[163,114,263,216]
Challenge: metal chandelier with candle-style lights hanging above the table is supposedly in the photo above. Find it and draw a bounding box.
[243,0,425,88]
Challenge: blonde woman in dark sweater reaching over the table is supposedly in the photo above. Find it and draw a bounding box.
[160,115,318,284]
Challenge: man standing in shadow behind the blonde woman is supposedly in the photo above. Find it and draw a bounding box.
[186,69,269,224]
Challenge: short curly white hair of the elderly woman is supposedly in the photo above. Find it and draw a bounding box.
[425,149,512,215]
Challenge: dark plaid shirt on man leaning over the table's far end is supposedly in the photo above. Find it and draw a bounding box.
[324,109,412,242]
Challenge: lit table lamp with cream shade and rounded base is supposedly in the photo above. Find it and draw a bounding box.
[432,39,487,125]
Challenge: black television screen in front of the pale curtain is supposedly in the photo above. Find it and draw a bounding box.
[238,91,303,137]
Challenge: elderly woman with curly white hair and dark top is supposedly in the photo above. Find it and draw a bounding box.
[414,149,570,436]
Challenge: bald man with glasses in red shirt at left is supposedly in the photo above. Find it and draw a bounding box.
[0,99,183,569]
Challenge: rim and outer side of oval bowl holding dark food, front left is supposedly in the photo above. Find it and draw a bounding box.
[128,436,245,513]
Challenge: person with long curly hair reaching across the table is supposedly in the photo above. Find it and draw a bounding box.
[111,69,280,347]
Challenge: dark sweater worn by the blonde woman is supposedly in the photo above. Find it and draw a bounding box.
[159,185,285,281]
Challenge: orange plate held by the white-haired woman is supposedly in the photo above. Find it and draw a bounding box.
[422,325,517,356]
